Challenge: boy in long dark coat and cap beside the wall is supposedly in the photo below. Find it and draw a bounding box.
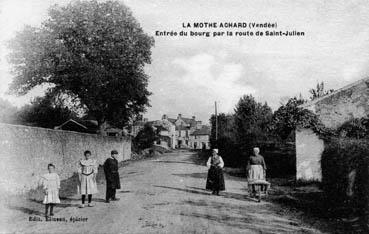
[104,150,120,203]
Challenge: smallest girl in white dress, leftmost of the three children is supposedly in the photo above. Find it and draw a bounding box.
[41,163,60,218]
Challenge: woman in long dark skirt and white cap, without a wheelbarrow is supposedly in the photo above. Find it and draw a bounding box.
[206,149,225,196]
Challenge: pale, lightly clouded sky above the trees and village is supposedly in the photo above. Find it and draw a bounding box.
[0,0,369,122]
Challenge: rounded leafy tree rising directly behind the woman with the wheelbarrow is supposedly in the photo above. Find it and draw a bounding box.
[235,95,273,151]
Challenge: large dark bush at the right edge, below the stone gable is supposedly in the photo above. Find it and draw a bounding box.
[321,138,369,216]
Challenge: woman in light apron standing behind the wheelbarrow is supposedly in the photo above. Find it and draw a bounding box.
[247,147,267,196]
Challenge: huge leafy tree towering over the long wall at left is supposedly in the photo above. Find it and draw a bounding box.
[9,1,154,127]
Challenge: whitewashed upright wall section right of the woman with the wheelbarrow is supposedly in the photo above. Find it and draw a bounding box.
[296,129,324,181]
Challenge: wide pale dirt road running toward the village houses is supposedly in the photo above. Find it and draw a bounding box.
[0,151,320,233]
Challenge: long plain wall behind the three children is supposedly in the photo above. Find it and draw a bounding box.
[0,123,131,194]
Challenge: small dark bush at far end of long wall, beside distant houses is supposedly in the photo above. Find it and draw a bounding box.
[133,123,159,151]
